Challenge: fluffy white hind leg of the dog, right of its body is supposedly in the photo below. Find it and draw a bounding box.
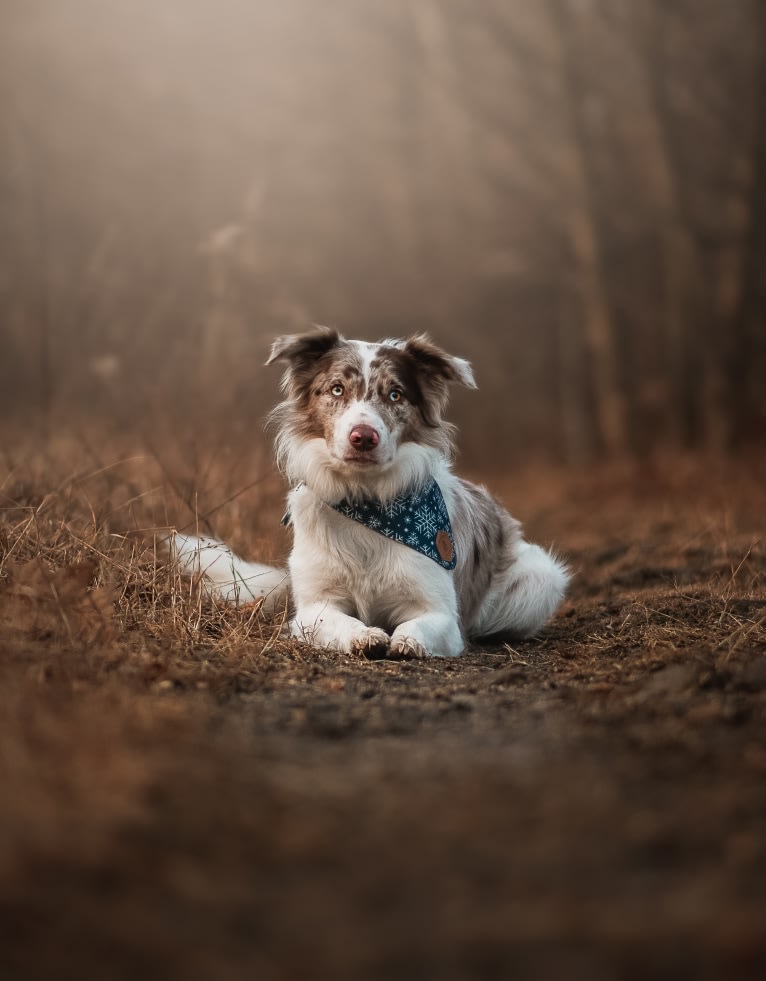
[468,541,570,638]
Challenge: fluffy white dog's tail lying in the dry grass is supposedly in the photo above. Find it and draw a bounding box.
[164,531,289,614]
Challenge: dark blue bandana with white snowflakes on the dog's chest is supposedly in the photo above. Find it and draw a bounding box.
[330,480,457,569]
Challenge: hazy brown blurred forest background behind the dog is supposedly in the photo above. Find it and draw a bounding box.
[0,0,766,465]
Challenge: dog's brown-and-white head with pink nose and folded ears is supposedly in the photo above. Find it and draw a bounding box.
[266,328,476,494]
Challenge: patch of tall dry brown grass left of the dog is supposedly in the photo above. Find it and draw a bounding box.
[0,424,284,654]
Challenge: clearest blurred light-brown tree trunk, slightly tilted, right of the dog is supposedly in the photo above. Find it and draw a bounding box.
[548,0,628,455]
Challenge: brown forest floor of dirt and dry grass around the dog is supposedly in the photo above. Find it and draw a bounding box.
[0,437,766,981]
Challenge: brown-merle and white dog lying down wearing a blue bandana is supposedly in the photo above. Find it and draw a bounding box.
[170,328,569,658]
